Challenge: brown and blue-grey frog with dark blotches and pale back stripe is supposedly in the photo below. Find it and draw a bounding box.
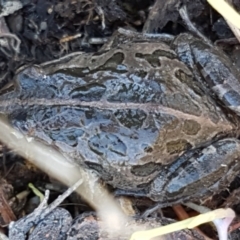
[0,30,240,206]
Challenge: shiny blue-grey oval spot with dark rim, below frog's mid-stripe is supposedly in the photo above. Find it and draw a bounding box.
[88,133,127,157]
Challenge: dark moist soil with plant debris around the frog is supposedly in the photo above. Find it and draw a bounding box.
[0,0,240,237]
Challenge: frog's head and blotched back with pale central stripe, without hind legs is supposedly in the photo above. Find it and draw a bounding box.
[0,37,235,189]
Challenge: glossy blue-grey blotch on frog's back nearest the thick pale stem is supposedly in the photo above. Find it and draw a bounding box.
[49,128,84,147]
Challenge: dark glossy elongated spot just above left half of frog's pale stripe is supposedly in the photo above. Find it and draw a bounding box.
[69,83,106,101]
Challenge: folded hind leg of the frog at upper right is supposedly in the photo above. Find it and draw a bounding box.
[174,34,240,116]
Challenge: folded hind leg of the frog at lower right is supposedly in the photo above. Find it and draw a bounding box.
[148,138,240,205]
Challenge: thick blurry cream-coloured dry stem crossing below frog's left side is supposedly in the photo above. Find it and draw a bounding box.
[0,121,127,231]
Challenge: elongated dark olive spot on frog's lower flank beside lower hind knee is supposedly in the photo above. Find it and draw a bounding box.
[131,162,162,177]
